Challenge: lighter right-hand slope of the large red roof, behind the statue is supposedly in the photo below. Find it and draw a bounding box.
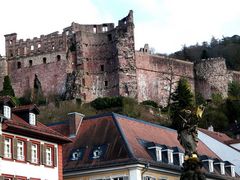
[115,115,218,160]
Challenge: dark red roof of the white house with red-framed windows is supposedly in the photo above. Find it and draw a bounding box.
[3,114,71,144]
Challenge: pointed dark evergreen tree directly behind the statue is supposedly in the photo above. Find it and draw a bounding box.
[170,78,194,129]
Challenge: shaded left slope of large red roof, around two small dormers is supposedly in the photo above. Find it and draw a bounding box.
[63,115,129,170]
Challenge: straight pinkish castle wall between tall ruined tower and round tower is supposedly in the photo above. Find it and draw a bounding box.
[136,49,194,106]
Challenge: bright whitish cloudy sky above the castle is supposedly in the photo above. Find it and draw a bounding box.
[0,0,240,55]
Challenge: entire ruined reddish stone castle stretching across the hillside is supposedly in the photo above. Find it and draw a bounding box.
[0,11,240,106]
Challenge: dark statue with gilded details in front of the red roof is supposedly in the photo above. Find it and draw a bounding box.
[177,106,205,180]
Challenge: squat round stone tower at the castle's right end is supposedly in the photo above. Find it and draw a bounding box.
[194,58,232,99]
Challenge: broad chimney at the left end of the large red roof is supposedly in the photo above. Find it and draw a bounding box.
[68,112,84,137]
